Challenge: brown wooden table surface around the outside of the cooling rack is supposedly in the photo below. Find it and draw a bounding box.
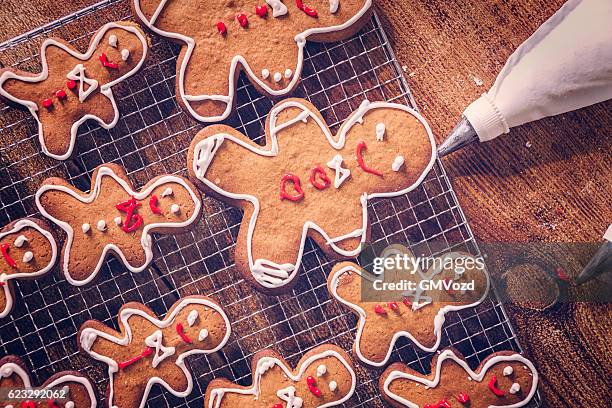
[0,0,612,407]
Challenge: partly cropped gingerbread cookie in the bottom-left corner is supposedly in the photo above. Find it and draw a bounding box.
[0,356,97,408]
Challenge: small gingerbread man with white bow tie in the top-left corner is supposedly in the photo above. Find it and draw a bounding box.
[0,22,147,160]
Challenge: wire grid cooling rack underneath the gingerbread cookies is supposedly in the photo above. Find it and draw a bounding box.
[0,0,539,407]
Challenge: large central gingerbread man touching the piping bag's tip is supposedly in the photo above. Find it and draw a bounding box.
[187,99,436,294]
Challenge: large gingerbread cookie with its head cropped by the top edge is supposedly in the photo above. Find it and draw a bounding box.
[134,0,372,122]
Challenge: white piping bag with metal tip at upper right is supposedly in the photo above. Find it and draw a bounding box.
[438,0,612,157]
